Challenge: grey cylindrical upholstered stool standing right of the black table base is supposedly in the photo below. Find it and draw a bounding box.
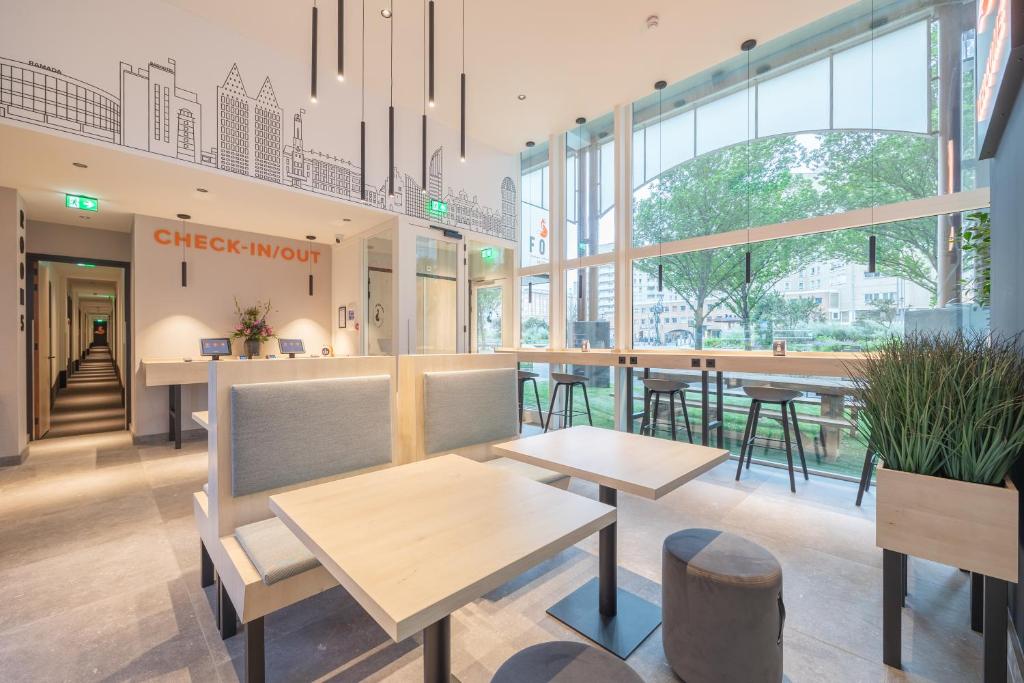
[662,528,785,683]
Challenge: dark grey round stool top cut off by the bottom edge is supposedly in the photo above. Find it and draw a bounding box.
[490,641,643,683]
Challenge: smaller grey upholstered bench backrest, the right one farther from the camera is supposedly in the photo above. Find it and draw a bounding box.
[423,368,519,454]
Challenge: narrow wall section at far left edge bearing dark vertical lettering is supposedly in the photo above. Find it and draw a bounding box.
[0,187,29,465]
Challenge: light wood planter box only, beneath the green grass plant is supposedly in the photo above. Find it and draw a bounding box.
[874,466,1018,584]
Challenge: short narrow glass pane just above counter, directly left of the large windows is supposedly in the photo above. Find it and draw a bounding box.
[565,263,615,348]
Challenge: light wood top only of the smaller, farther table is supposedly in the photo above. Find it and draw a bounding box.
[493,426,729,500]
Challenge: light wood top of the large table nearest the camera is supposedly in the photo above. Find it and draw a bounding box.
[269,455,615,642]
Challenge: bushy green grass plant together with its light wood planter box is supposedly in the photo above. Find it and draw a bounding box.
[854,333,1024,583]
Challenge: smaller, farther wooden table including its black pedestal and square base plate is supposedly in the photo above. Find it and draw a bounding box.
[494,426,729,659]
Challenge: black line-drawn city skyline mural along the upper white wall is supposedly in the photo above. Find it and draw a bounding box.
[0,57,518,240]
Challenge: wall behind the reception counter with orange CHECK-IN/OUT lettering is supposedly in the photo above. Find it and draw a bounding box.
[132,216,333,435]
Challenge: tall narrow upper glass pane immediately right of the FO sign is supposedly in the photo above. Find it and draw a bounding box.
[565,114,615,258]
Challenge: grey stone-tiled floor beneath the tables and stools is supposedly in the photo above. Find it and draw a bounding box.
[0,432,981,683]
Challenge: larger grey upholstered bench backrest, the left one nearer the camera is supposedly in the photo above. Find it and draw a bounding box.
[231,375,391,496]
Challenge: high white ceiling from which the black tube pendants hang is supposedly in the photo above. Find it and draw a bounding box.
[159,0,854,153]
